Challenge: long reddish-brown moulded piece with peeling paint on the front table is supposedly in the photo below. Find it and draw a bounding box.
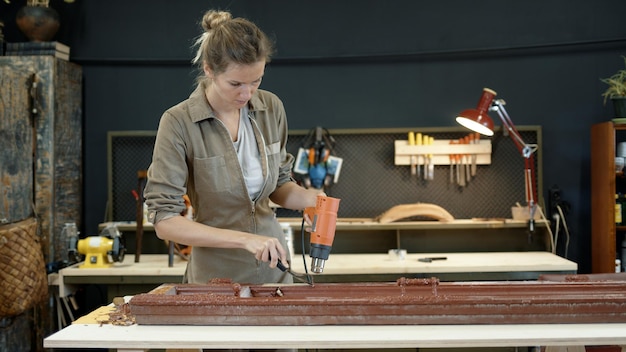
[129,278,626,325]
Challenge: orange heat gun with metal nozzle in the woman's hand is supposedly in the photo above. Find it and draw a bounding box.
[304,195,340,274]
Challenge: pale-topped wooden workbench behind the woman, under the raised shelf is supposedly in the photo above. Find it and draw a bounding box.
[56,252,578,302]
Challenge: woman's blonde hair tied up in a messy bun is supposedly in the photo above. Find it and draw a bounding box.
[192,10,273,80]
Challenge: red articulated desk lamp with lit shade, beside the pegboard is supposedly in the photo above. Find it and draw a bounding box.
[456,88,537,233]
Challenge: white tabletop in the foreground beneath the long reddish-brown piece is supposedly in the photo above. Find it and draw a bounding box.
[43,323,626,352]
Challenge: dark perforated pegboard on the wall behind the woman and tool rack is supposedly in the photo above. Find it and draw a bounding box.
[107,126,543,221]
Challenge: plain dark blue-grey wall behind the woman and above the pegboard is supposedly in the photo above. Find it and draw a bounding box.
[0,0,626,272]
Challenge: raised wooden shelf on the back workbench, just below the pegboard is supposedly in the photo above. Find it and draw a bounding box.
[100,217,552,254]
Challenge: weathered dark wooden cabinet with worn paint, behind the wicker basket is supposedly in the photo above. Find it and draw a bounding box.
[0,56,83,351]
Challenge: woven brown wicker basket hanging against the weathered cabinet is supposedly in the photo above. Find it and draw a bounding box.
[0,218,48,317]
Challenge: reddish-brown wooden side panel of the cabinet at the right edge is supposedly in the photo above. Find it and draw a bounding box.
[591,121,626,273]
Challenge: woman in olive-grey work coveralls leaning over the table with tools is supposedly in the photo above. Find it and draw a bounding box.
[144,10,320,283]
